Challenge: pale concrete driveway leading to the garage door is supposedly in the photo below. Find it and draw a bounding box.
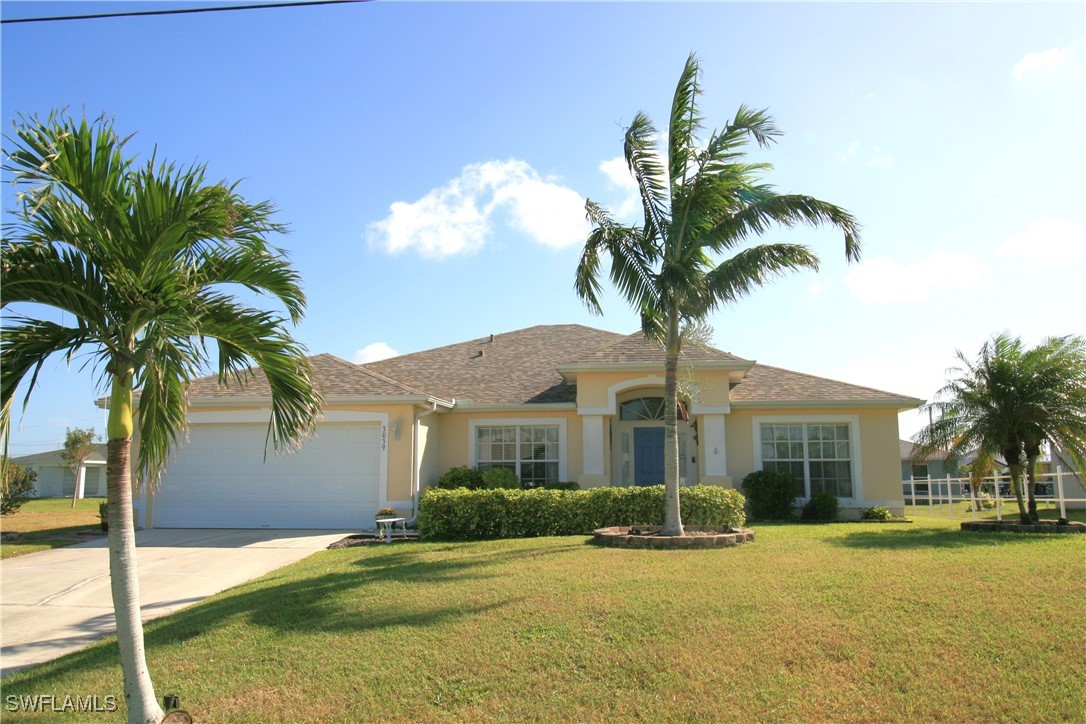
[0,530,352,675]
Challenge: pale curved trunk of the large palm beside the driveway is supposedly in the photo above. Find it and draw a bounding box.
[105,373,163,724]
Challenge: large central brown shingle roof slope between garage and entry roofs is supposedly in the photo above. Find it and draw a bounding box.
[362,325,621,405]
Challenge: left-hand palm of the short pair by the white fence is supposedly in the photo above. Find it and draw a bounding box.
[914,333,1030,522]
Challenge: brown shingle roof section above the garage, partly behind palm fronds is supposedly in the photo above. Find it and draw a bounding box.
[189,354,426,398]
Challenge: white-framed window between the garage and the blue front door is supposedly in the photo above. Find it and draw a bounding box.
[476,424,559,487]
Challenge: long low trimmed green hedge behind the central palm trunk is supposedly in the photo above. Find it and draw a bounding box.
[418,485,746,541]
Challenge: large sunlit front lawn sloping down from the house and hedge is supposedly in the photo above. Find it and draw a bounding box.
[4,519,1086,722]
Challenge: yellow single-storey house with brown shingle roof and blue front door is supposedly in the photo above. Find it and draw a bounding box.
[137,325,922,529]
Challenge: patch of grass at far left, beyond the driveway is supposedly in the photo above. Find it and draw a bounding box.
[0,498,105,558]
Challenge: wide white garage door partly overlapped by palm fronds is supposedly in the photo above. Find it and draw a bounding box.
[152,423,381,529]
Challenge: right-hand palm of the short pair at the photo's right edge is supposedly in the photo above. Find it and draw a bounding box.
[1022,336,1086,522]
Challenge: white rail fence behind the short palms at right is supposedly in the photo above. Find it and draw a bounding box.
[901,468,1086,520]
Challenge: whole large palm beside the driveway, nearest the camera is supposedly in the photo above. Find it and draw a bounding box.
[0,113,320,722]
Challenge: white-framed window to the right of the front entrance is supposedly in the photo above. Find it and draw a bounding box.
[760,422,854,498]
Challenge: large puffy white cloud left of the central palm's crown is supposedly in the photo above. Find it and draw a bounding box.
[366,158,589,259]
